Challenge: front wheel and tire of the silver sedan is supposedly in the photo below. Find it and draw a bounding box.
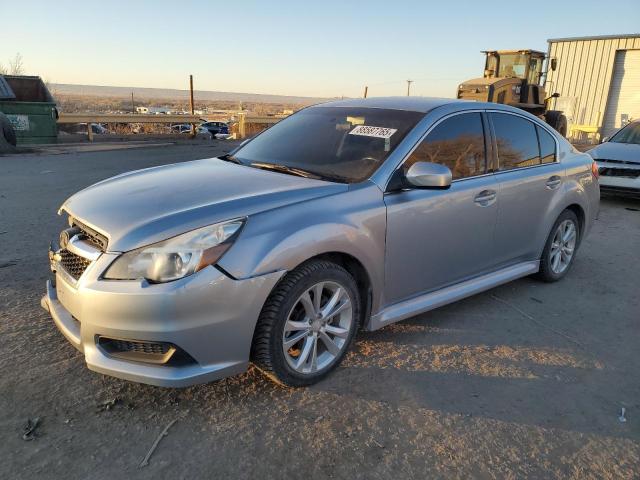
[251,260,361,387]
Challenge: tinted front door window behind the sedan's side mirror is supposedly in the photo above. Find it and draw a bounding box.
[403,113,487,180]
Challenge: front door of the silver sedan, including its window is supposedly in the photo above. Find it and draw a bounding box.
[384,111,498,304]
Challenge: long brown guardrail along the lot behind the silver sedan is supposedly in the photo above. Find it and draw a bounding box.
[58,112,285,142]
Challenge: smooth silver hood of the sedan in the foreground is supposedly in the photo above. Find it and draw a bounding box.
[60,158,348,252]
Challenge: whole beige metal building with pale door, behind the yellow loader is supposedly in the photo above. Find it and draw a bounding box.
[545,34,640,139]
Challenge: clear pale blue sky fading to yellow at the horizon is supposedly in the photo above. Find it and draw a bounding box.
[0,0,640,97]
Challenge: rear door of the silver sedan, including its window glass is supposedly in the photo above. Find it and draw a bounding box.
[489,112,565,265]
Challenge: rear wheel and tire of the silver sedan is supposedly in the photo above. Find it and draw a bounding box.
[537,210,580,282]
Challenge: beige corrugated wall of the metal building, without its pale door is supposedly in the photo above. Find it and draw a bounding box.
[545,36,640,137]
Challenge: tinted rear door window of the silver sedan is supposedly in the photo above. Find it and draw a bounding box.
[491,113,540,171]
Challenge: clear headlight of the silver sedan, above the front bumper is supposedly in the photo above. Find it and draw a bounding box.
[104,220,244,283]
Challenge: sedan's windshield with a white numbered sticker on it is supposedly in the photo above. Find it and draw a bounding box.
[232,107,424,183]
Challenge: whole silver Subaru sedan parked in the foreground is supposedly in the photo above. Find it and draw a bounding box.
[42,97,599,386]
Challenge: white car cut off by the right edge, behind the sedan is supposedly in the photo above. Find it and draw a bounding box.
[587,120,640,198]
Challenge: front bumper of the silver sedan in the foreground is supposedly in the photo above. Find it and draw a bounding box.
[41,253,283,387]
